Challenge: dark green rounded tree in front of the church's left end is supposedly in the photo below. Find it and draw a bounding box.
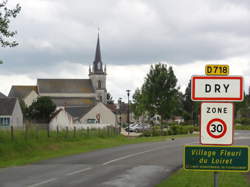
[28,96,56,123]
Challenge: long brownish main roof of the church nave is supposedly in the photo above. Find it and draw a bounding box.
[37,79,94,93]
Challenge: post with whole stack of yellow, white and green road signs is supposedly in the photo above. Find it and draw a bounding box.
[186,65,246,187]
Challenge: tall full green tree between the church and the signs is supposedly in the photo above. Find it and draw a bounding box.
[142,63,179,121]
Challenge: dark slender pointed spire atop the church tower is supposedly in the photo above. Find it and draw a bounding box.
[93,32,104,74]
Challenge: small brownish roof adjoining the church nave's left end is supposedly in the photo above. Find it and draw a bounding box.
[8,85,37,99]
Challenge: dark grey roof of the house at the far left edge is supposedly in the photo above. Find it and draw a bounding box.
[0,97,17,116]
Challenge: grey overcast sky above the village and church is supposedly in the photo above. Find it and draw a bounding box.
[0,0,250,102]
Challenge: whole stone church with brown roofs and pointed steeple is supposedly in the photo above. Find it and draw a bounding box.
[8,33,107,108]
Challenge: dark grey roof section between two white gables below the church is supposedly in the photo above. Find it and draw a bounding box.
[65,105,95,118]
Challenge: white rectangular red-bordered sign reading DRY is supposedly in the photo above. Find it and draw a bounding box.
[191,76,244,101]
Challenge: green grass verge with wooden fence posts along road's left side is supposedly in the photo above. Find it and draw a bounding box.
[0,127,195,167]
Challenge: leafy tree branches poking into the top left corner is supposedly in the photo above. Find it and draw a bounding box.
[0,0,21,47]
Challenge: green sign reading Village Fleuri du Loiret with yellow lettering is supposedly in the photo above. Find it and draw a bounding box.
[183,145,249,172]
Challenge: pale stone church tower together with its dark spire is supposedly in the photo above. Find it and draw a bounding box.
[89,33,107,104]
